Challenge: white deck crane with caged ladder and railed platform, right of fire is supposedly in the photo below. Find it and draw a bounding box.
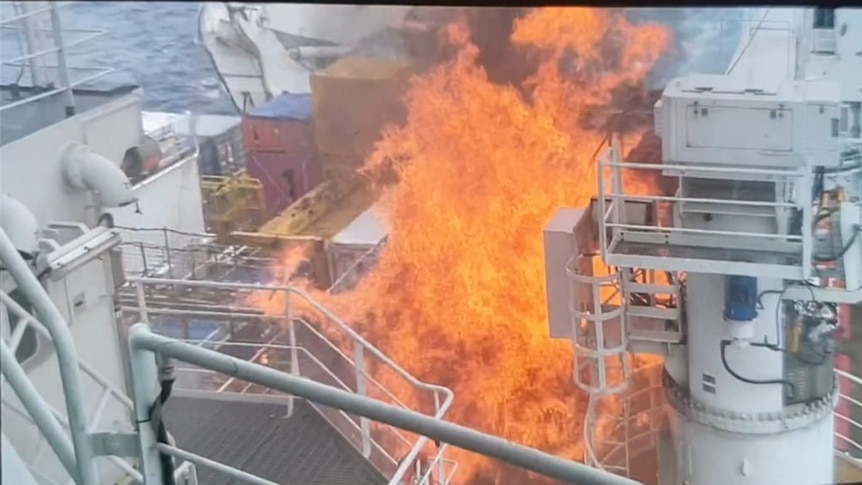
[545,9,862,485]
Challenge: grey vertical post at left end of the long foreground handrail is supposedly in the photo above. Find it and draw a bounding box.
[129,323,162,484]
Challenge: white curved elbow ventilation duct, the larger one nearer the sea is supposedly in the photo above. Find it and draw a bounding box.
[62,143,138,208]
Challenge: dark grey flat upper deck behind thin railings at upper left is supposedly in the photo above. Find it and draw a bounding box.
[0,84,138,146]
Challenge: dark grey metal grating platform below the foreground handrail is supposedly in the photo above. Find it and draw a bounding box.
[165,396,387,485]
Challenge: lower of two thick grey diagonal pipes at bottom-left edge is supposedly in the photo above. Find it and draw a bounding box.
[0,336,78,477]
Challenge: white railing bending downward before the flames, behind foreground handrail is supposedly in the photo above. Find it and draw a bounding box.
[121,278,456,485]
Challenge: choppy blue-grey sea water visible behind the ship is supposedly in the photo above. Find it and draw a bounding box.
[0,2,753,113]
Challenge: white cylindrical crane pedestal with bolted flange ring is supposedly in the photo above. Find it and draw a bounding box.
[662,274,834,485]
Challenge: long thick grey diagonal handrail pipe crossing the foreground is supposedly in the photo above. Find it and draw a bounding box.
[129,323,641,485]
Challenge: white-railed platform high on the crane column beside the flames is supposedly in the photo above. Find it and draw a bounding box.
[596,136,813,280]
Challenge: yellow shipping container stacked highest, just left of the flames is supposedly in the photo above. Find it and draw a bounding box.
[311,57,414,159]
